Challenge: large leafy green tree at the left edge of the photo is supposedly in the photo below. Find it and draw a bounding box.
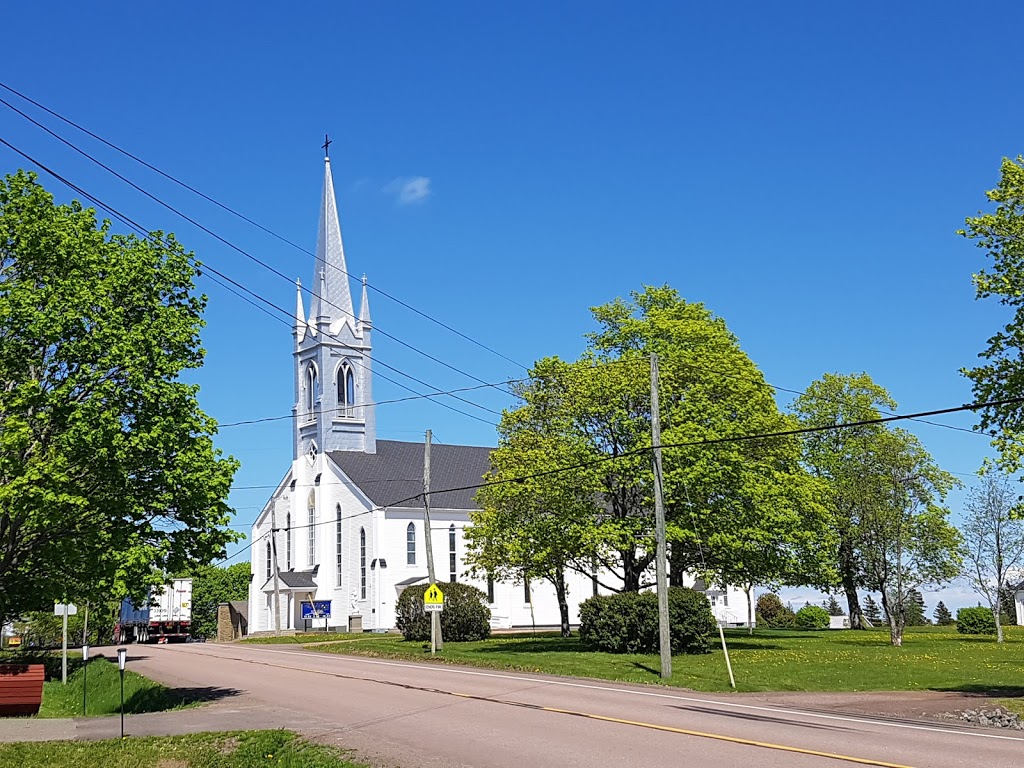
[0,172,237,620]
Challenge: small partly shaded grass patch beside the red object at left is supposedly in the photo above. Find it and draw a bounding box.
[37,656,193,720]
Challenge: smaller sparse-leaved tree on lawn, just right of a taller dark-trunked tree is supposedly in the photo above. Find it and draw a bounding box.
[860,429,961,645]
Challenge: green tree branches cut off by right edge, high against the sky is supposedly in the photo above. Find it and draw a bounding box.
[957,156,1024,471]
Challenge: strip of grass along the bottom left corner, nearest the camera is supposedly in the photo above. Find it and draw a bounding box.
[0,731,366,768]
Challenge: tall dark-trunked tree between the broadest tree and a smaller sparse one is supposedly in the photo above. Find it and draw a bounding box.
[793,373,896,629]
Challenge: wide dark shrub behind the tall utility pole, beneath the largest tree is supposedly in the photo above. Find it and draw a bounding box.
[580,587,716,653]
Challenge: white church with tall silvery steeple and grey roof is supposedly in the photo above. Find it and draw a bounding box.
[243,150,746,633]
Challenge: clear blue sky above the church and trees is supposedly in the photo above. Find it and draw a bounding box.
[0,2,1024,604]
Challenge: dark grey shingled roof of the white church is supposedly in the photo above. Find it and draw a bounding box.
[328,440,494,510]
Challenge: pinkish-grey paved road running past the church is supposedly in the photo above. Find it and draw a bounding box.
[121,644,1024,768]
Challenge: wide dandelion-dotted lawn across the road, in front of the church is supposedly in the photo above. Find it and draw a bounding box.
[317,627,1024,698]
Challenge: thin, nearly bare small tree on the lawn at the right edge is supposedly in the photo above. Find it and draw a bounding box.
[963,467,1024,643]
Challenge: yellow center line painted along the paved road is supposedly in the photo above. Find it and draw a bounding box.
[165,651,912,768]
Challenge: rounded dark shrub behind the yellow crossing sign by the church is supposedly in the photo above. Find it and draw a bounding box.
[395,583,490,643]
